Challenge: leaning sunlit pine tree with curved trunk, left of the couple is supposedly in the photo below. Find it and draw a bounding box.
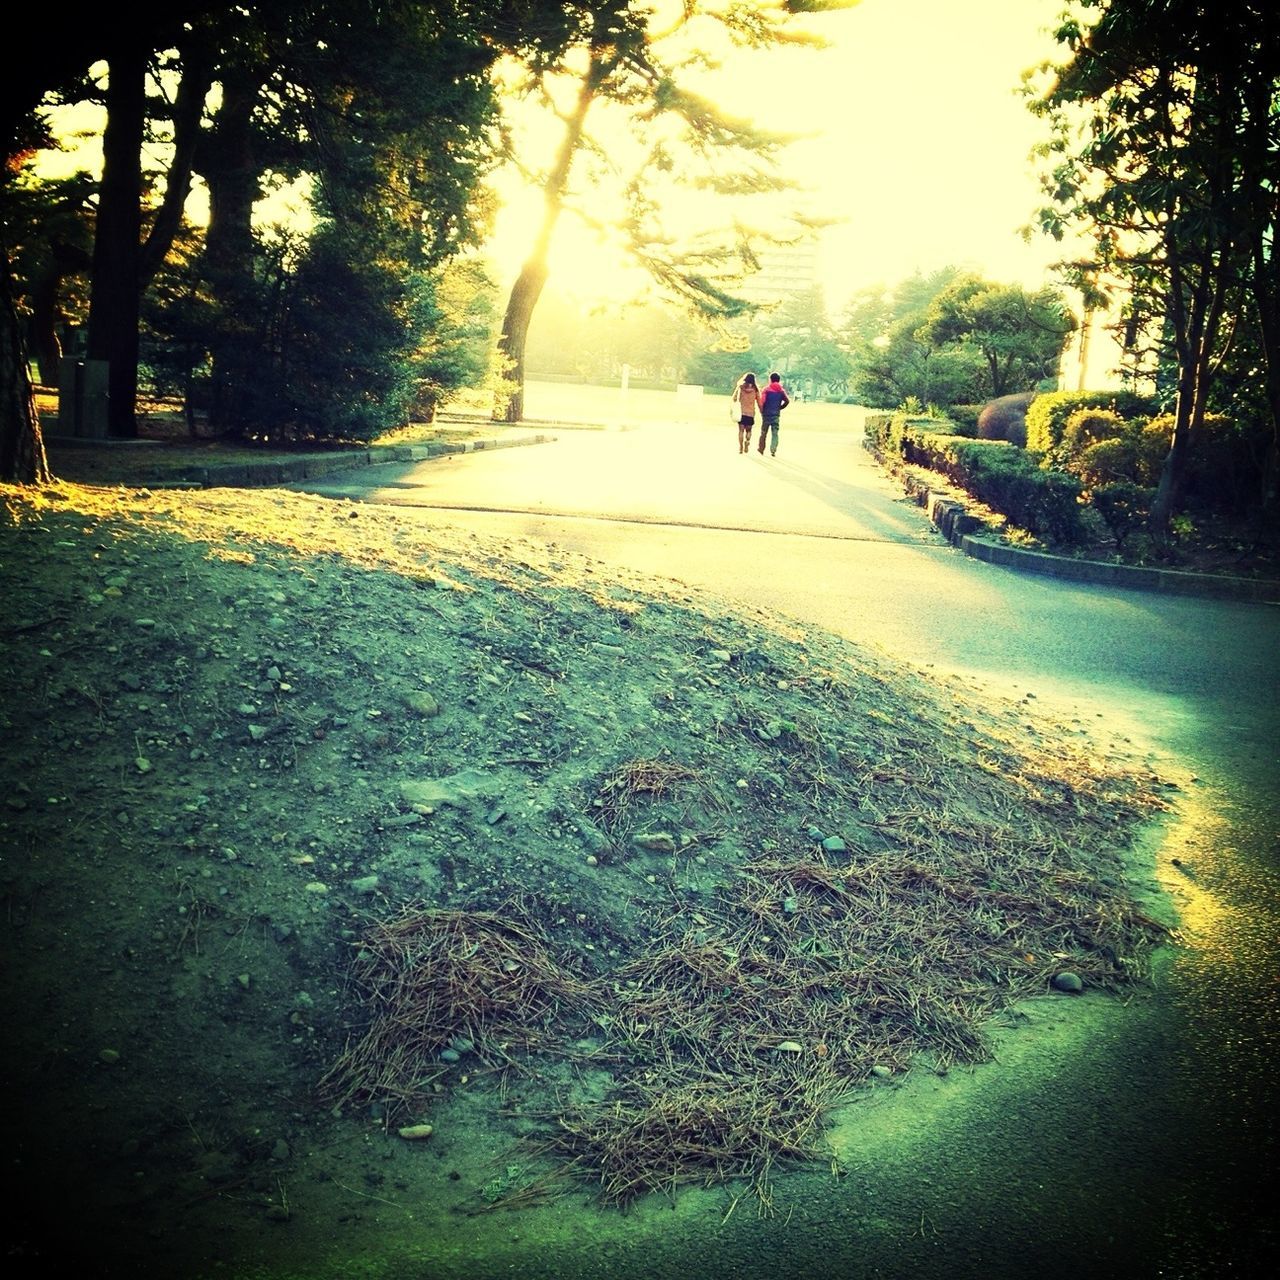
[500,0,856,421]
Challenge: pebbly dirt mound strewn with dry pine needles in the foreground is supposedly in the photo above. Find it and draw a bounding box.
[0,485,1160,1275]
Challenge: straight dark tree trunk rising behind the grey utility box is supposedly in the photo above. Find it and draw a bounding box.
[86,45,148,436]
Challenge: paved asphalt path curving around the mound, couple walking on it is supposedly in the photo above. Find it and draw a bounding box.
[296,417,1280,1280]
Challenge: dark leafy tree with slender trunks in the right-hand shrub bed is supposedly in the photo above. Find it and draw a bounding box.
[1032,0,1280,540]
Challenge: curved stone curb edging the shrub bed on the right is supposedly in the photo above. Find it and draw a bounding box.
[899,460,1280,604]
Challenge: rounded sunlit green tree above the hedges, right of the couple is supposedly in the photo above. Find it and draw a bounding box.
[919,275,1075,399]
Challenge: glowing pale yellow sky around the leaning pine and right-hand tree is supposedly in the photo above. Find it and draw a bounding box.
[493,0,1064,315]
